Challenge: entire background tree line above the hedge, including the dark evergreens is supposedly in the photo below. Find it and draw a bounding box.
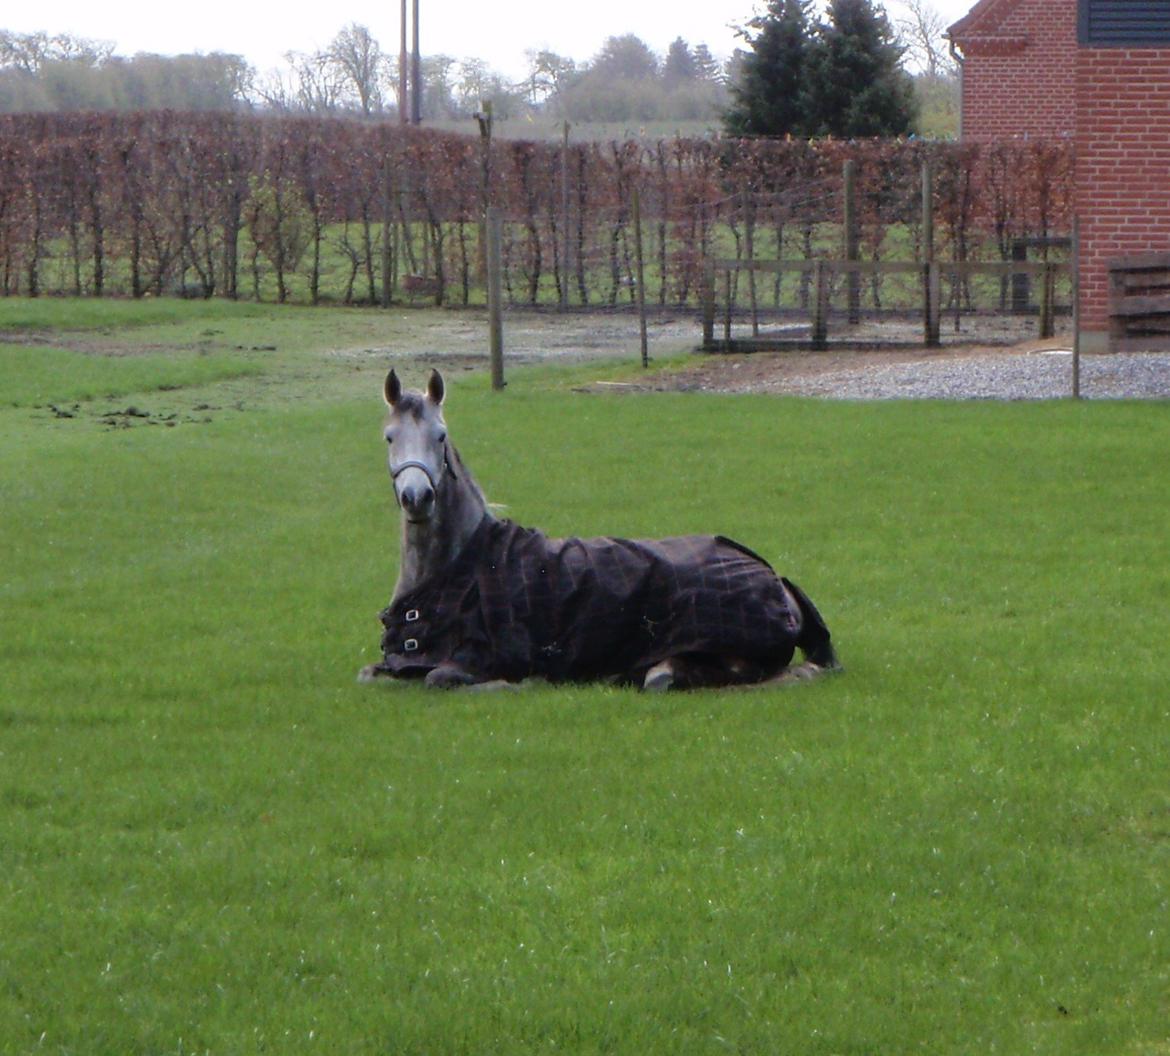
[0,0,955,134]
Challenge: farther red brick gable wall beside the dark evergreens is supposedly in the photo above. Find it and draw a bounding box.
[956,0,1076,142]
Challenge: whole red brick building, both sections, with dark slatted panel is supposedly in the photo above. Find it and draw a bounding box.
[948,0,1170,351]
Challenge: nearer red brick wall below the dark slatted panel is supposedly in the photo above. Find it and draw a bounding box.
[1076,48,1170,344]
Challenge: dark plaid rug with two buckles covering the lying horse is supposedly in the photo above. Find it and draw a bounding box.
[377,516,830,682]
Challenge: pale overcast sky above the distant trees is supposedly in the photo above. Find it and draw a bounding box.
[0,0,975,78]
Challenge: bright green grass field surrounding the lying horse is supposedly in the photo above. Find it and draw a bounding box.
[0,302,1170,1056]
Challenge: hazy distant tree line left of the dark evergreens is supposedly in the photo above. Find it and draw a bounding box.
[0,23,728,122]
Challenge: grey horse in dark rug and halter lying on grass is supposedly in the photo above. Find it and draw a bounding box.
[358,371,839,691]
